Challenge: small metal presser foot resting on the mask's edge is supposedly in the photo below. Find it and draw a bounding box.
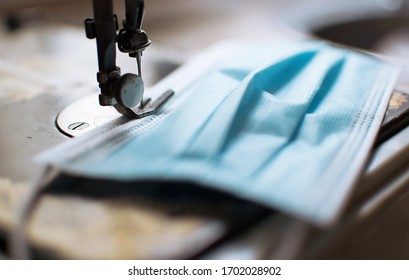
[114,90,175,119]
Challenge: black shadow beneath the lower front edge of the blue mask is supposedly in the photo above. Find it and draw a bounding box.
[46,175,269,224]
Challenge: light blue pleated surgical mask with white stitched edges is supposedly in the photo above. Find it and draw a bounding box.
[39,41,396,226]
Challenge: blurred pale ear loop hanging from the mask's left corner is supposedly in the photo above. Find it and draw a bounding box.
[9,166,58,260]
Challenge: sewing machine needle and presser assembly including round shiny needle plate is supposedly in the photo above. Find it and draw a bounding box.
[56,0,174,136]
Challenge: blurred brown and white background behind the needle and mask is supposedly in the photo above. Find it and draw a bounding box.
[0,0,409,83]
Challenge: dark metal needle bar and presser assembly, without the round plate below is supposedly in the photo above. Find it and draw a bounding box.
[84,0,173,118]
